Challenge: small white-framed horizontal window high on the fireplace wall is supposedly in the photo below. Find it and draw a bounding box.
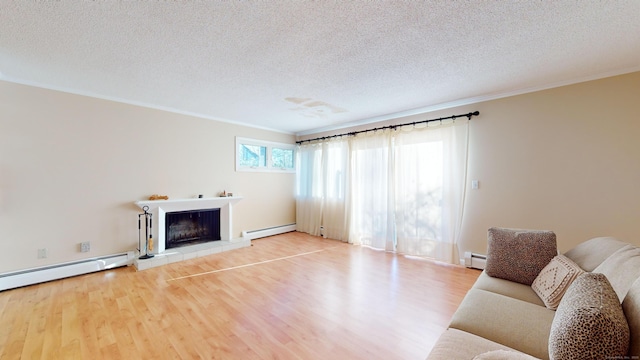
[236,137,295,172]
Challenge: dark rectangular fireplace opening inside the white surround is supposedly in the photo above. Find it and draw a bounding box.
[165,209,220,249]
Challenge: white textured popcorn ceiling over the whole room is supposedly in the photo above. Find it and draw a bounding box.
[0,0,640,134]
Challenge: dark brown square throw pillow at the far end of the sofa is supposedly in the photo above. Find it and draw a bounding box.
[484,227,558,285]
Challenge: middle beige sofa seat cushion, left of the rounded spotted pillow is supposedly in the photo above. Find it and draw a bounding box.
[449,289,555,359]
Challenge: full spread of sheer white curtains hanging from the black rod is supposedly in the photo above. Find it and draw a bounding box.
[297,119,469,263]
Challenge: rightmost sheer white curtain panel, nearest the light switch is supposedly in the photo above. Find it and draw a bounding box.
[394,119,468,263]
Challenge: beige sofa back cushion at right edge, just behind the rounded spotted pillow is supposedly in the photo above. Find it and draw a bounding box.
[593,245,640,302]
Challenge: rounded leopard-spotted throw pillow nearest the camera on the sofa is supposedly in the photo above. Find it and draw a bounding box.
[549,273,630,360]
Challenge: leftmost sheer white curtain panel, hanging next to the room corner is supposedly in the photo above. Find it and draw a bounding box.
[296,139,349,241]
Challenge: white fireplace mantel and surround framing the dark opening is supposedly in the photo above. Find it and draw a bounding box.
[135,196,242,254]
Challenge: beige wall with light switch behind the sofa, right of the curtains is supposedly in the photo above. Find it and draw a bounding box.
[298,72,640,253]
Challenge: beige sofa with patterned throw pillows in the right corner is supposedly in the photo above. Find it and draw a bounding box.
[427,232,640,360]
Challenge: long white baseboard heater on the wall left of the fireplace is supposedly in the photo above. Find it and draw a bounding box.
[0,251,134,291]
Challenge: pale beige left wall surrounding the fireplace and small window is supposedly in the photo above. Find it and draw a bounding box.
[0,81,295,273]
